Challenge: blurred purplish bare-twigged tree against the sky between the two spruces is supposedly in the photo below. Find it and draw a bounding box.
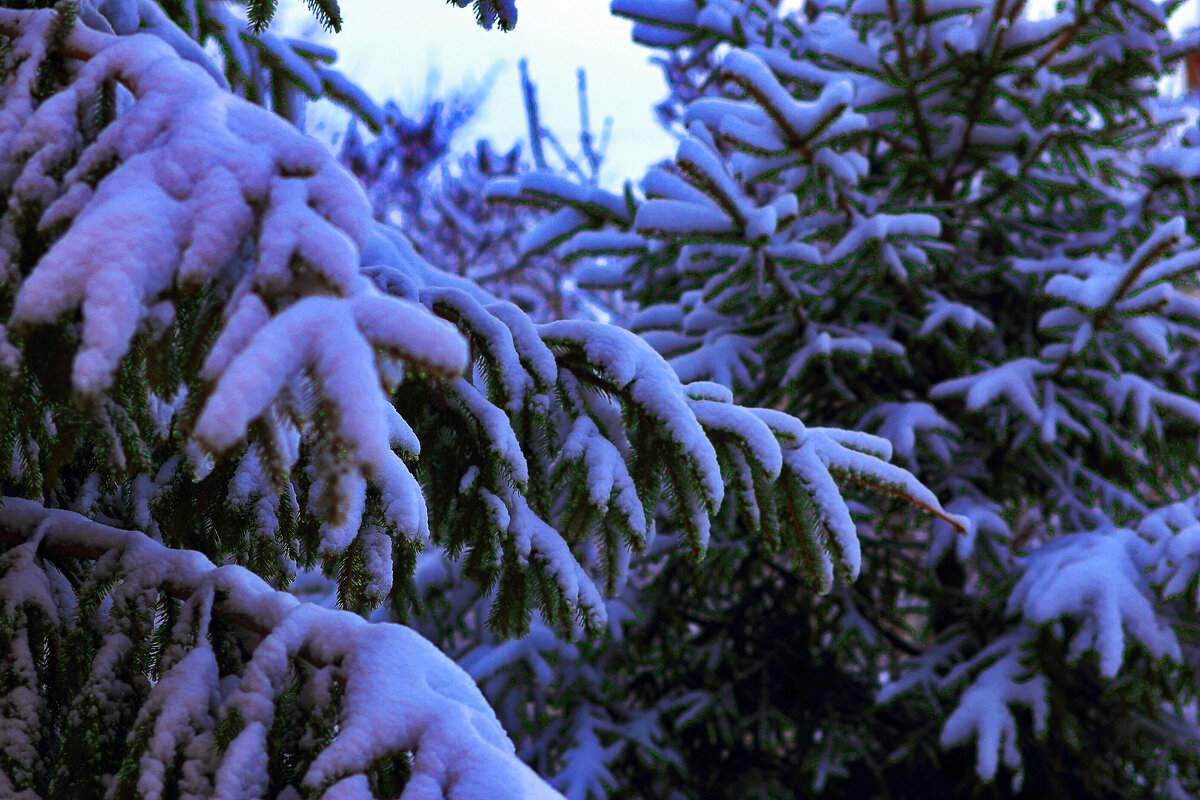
[338,61,617,321]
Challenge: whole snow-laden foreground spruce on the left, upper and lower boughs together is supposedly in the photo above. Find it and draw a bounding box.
[0,2,966,800]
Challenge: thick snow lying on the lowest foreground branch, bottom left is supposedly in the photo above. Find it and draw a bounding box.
[0,498,562,800]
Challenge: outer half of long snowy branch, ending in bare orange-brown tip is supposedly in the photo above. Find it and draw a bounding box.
[372,228,966,606]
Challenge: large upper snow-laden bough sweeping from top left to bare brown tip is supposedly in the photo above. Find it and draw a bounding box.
[0,1,964,631]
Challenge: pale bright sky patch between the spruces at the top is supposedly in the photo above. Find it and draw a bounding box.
[280,0,674,185]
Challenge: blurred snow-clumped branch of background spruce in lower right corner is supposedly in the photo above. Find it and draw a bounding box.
[880,506,1200,780]
